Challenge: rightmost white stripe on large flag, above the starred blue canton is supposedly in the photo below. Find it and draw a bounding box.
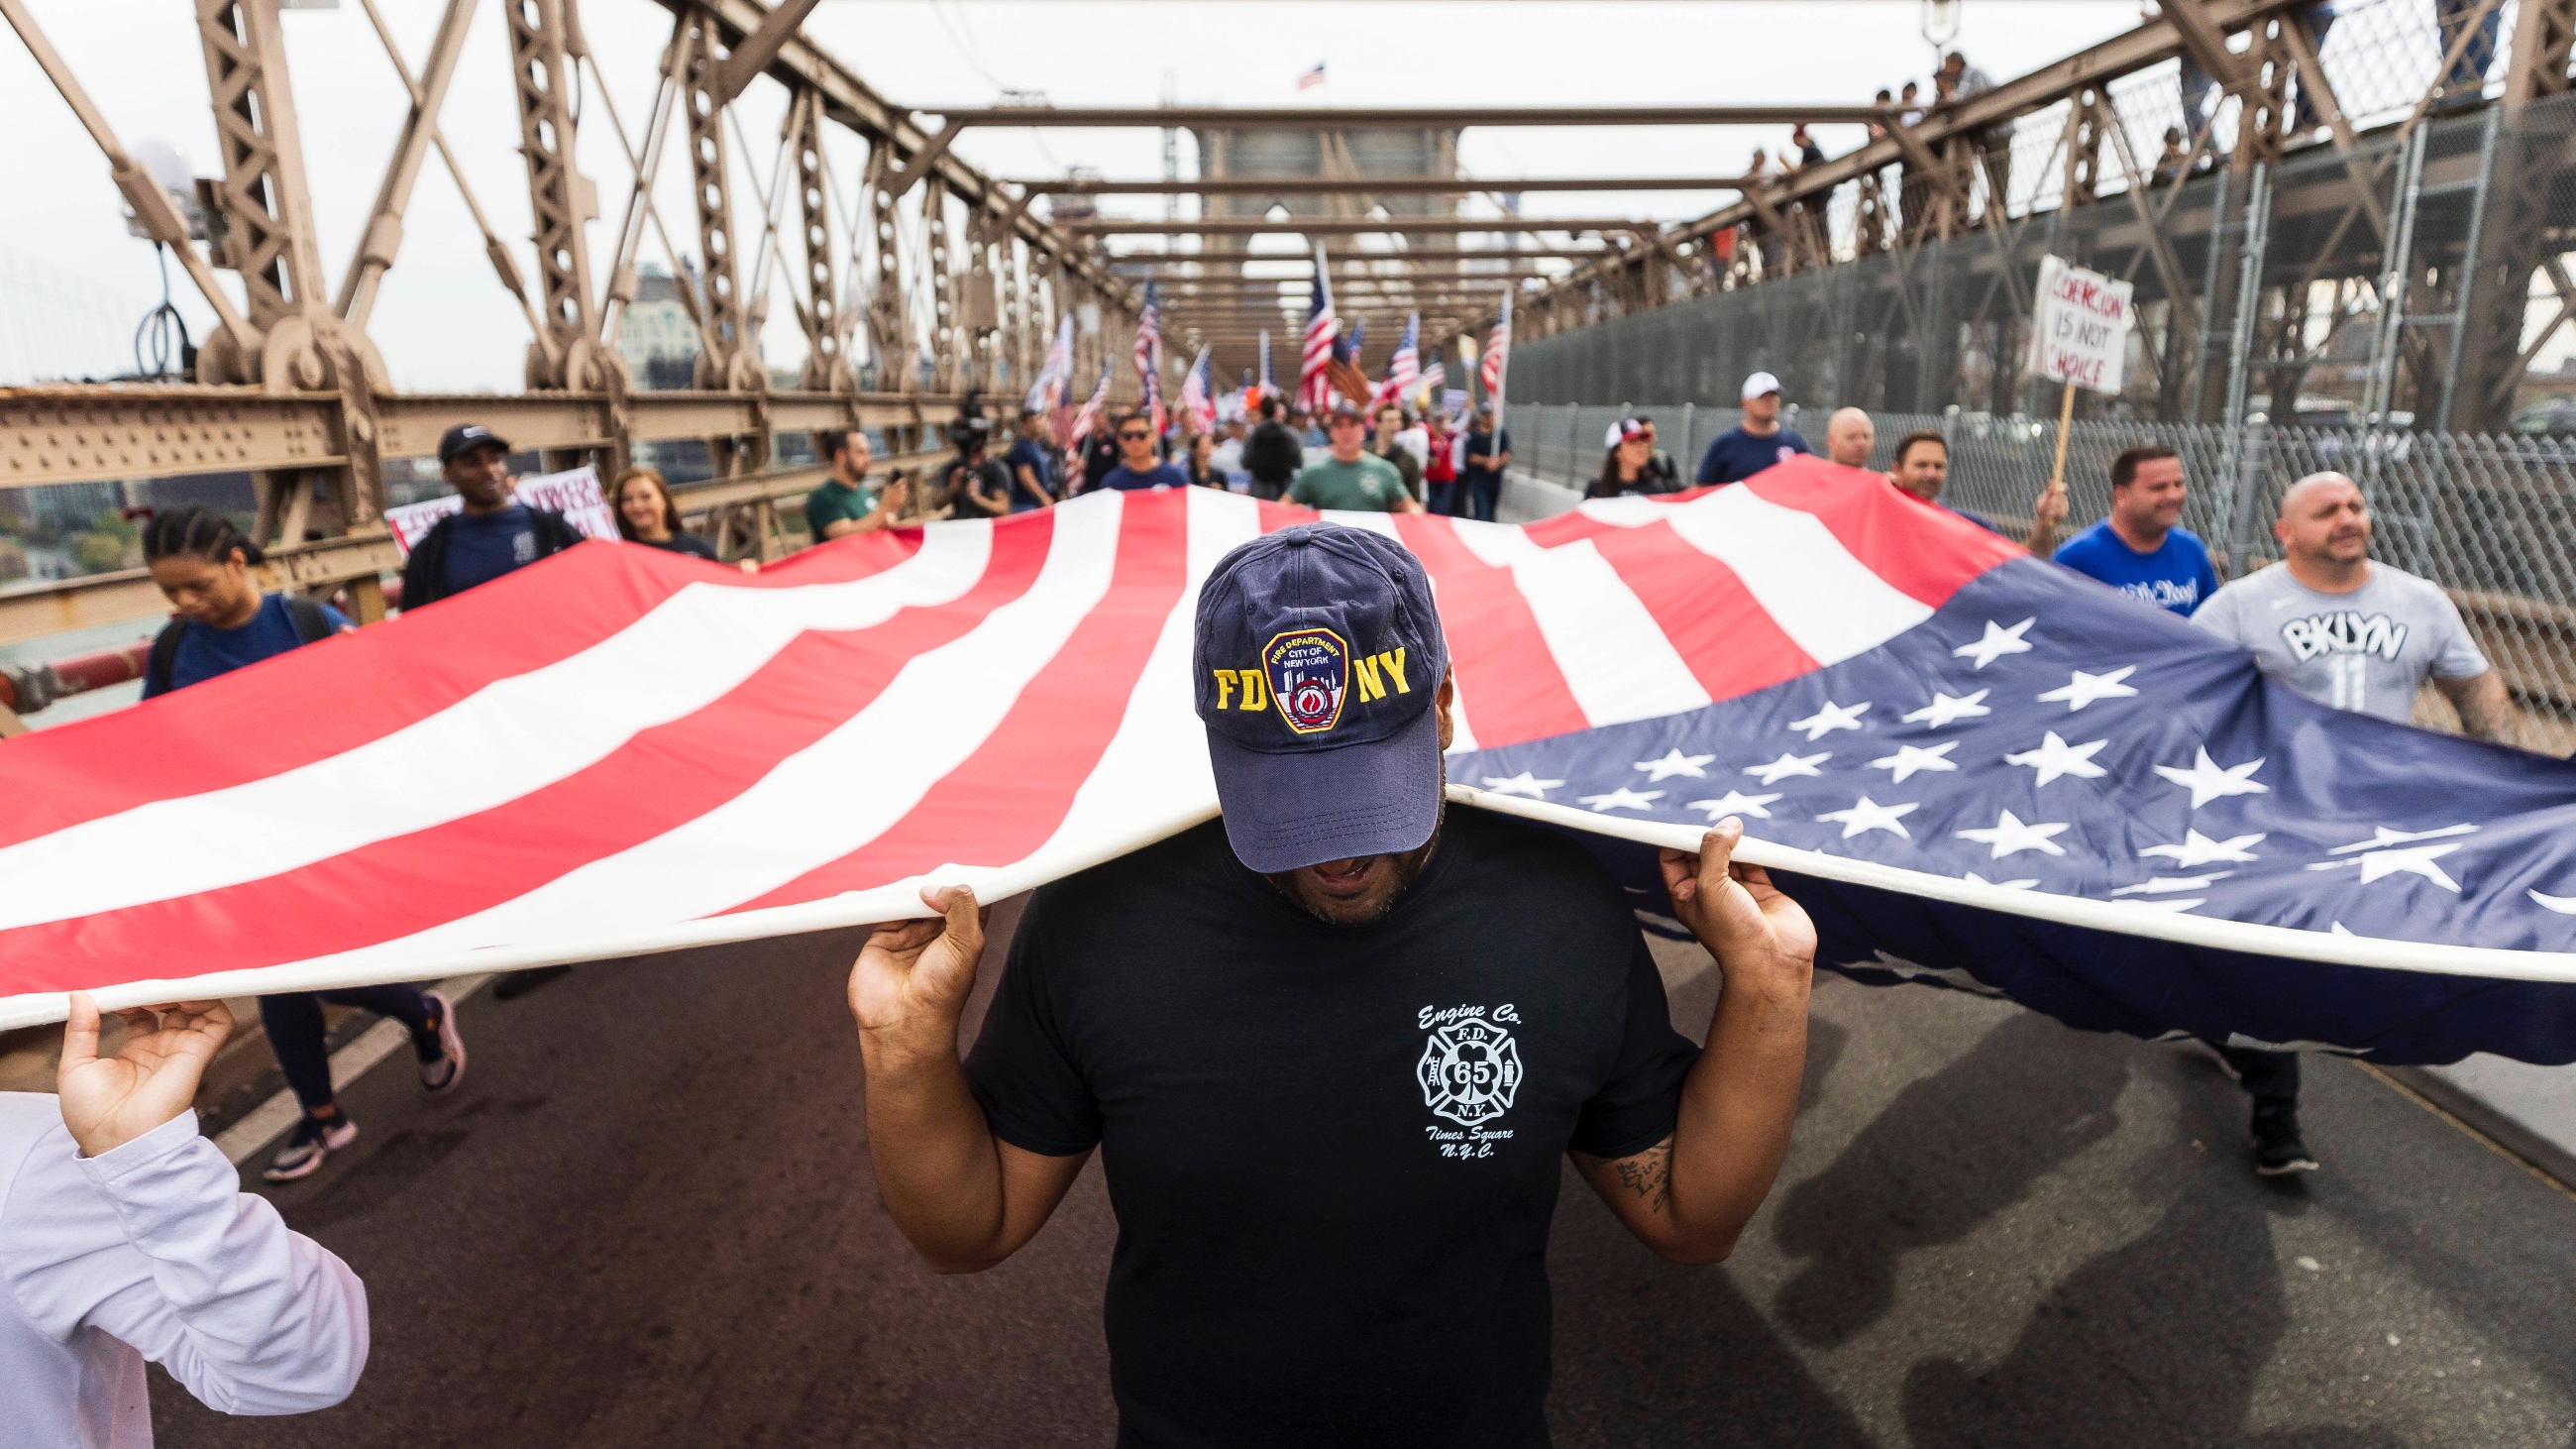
[1649,488,1932,665]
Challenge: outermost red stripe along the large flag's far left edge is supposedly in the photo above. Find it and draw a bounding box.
[0,528,919,845]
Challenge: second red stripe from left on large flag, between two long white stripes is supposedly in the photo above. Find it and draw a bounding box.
[0,523,1053,995]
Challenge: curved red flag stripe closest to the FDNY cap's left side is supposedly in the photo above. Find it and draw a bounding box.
[734,498,1190,910]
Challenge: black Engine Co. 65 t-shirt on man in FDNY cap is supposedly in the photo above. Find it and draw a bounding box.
[966,810,1697,1449]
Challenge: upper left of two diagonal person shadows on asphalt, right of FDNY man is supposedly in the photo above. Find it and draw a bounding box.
[1774,1013,2128,1346]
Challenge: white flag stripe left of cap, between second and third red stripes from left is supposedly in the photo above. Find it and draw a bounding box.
[273,490,1124,967]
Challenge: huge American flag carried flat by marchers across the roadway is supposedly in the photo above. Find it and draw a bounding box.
[15,459,2576,1062]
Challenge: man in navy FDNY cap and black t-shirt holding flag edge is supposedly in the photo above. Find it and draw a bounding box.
[850,523,1816,1449]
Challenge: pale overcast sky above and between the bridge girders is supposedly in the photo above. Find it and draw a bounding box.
[0,0,2138,391]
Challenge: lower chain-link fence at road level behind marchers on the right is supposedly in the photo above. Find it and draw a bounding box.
[1504,402,2576,737]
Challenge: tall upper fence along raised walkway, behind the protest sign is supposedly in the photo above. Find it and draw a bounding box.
[1512,0,2576,433]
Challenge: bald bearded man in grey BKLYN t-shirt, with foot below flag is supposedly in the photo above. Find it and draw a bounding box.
[2193,472,2515,1175]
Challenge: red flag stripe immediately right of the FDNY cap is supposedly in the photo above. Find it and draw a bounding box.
[1396,513,1592,750]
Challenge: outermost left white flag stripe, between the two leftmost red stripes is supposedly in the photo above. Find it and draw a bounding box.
[0,520,992,931]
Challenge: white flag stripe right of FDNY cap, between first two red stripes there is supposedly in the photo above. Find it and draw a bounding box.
[1512,539,1708,729]
